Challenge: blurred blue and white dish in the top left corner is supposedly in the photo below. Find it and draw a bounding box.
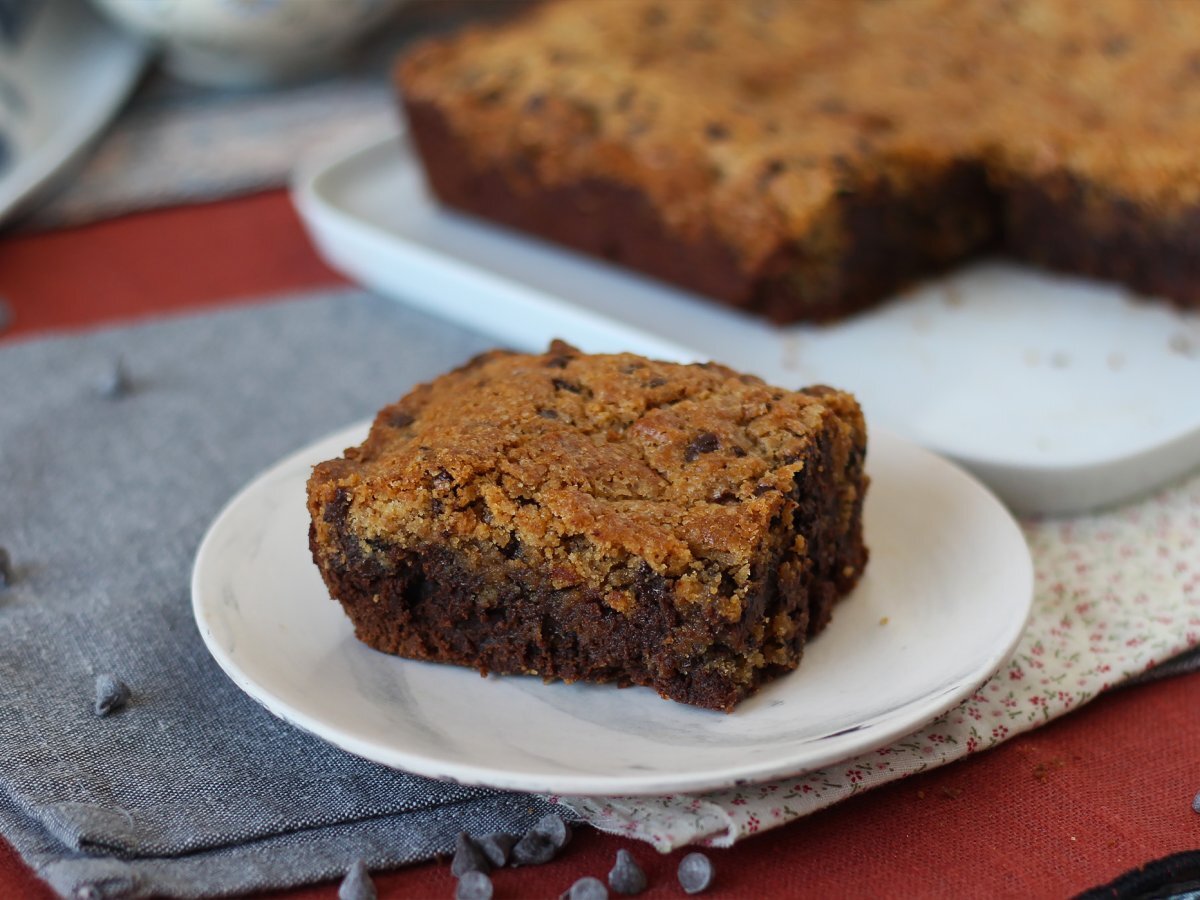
[0,0,148,222]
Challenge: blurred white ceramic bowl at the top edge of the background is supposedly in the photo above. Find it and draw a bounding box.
[92,0,404,85]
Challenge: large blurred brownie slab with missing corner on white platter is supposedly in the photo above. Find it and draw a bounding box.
[396,0,1200,322]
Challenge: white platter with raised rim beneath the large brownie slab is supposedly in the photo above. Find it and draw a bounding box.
[294,134,1200,514]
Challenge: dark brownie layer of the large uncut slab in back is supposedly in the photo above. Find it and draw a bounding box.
[407,87,1200,324]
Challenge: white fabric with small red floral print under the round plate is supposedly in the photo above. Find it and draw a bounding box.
[556,474,1200,852]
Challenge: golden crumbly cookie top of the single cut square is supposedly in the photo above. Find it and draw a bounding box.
[310,344,865,620]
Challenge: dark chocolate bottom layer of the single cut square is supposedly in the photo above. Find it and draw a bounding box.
[310,475,866,710]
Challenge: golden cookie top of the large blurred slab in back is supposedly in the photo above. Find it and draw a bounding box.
[400,0,1200,303]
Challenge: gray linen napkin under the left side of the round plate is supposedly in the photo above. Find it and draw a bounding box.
[0,290,568,898]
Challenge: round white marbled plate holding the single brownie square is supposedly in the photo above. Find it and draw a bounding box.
[192,425,1033,794]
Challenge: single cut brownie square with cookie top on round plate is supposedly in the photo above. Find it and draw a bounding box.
[308,342,866,710]
